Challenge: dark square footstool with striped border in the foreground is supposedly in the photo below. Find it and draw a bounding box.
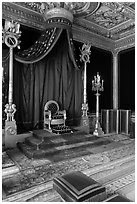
[53,171,107,202]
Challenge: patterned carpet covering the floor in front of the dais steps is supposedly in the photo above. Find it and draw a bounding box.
[2,135,135,202]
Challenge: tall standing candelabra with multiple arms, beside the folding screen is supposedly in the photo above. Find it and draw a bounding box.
[92,72,104,136]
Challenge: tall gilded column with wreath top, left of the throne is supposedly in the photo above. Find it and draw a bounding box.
[2,21,21,147]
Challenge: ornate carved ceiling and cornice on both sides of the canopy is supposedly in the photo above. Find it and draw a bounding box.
[2,2,135,52]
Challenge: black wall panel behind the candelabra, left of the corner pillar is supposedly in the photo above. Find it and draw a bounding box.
[87,47,112,112]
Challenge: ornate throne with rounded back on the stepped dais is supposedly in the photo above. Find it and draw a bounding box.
[44,100,66,130]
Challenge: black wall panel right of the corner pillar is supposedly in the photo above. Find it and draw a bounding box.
[119,48,135,111]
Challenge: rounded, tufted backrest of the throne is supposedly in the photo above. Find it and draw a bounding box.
[45,100,59,114]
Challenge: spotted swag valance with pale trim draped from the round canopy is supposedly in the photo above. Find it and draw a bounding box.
[15,18,80,69]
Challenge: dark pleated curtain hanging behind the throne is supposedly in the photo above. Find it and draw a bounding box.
[2,29,82,130]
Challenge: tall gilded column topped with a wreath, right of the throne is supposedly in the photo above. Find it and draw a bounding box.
[80,43,91,132]
